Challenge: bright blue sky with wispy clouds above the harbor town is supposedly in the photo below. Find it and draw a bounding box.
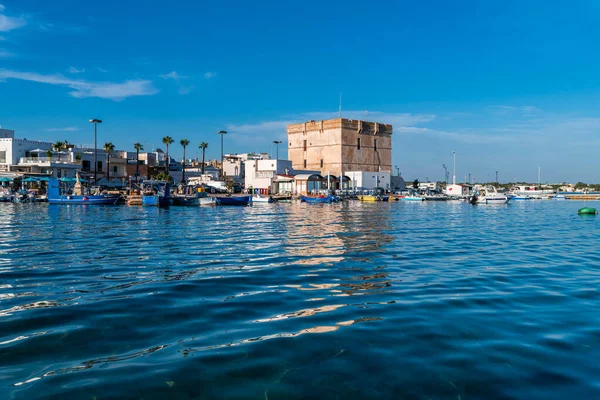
[0,0,600,182]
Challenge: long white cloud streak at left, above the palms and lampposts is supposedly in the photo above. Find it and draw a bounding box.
[0,69,158,101]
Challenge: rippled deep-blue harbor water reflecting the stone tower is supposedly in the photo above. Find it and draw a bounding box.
[0,201,600,400]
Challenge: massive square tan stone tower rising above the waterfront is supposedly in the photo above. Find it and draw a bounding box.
[287,118,392,177]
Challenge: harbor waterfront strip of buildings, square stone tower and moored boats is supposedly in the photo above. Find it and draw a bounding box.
[0,118,600,205]
